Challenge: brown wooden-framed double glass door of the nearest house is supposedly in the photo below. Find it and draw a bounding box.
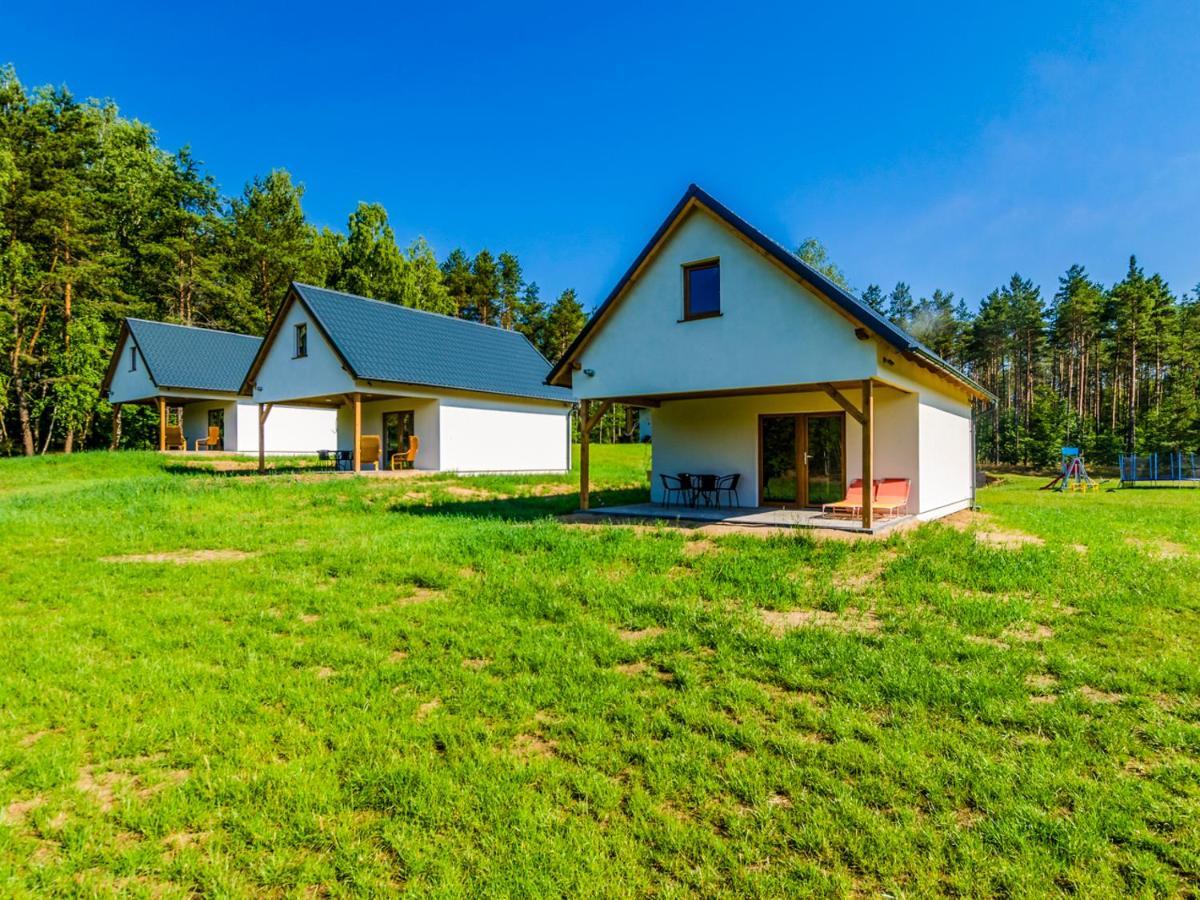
[758,413,846,506]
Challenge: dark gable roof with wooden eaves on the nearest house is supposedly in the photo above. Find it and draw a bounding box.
[546,185,995,400]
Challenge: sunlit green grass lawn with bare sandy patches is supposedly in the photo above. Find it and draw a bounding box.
[0,446,1200,896]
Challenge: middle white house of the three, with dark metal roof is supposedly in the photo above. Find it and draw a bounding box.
[242,283,574,473]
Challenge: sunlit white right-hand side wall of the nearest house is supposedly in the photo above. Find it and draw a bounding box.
[920,397,974,518]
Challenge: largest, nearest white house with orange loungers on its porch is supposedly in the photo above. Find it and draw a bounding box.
[548,185,990,529]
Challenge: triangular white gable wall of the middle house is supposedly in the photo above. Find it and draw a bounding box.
[253,301,355,403]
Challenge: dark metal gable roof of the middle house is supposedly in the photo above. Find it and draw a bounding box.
[244,282,571,403]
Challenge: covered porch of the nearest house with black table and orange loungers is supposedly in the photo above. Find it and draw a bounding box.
[580,378,920,534]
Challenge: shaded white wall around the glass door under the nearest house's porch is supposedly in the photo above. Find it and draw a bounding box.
[650,388,920,510]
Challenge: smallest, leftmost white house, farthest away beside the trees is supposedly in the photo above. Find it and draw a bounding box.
[102,318,337,454]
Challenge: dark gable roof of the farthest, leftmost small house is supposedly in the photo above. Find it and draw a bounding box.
[102,318,263,394]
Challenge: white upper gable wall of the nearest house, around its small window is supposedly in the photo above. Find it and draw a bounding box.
[571,210,877,400]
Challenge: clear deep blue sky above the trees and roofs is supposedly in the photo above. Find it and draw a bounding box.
[0,0,1200,307]
